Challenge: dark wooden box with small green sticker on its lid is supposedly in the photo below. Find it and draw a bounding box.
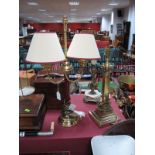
[19,94,46,130]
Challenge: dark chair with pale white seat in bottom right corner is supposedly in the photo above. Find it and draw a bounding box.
[91,119,135,155]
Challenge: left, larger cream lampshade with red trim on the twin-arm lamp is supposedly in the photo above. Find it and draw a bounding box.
[26,32,65,63]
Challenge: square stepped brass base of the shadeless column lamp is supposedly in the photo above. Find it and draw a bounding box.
[89,105,118,127]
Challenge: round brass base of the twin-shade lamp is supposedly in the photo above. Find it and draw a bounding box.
[58,110,80,127]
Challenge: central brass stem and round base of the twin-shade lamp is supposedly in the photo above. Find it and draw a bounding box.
[58,17,80,127]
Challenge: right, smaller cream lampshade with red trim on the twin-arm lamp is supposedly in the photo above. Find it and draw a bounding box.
[67,34,100,60]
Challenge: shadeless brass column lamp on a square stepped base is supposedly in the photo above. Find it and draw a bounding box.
[89,48,117,127]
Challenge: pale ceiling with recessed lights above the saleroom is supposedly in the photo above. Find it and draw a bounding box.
[19,0,130,23]
